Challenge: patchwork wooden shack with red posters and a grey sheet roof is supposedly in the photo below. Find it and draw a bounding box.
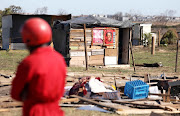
[53,16,132,66]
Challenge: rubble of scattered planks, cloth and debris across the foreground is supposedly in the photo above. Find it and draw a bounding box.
[0,74,180,115]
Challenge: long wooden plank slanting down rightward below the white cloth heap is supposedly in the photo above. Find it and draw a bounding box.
[71,95,123,111]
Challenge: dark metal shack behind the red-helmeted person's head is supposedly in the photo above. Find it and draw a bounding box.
[2,14,71,49]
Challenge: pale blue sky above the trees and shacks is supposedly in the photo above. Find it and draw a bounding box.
[0,0,180,17]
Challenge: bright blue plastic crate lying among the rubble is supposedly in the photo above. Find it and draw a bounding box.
[124,80,149,99]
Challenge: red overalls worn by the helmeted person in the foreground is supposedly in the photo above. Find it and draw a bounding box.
[11,47,66,116]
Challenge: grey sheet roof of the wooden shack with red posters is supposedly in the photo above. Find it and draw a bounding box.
[61,16,133,28]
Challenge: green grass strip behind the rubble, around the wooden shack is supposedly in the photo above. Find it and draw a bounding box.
[0,46,180,74]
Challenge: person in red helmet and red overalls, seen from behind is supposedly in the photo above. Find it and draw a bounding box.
[11,18,66,116]
